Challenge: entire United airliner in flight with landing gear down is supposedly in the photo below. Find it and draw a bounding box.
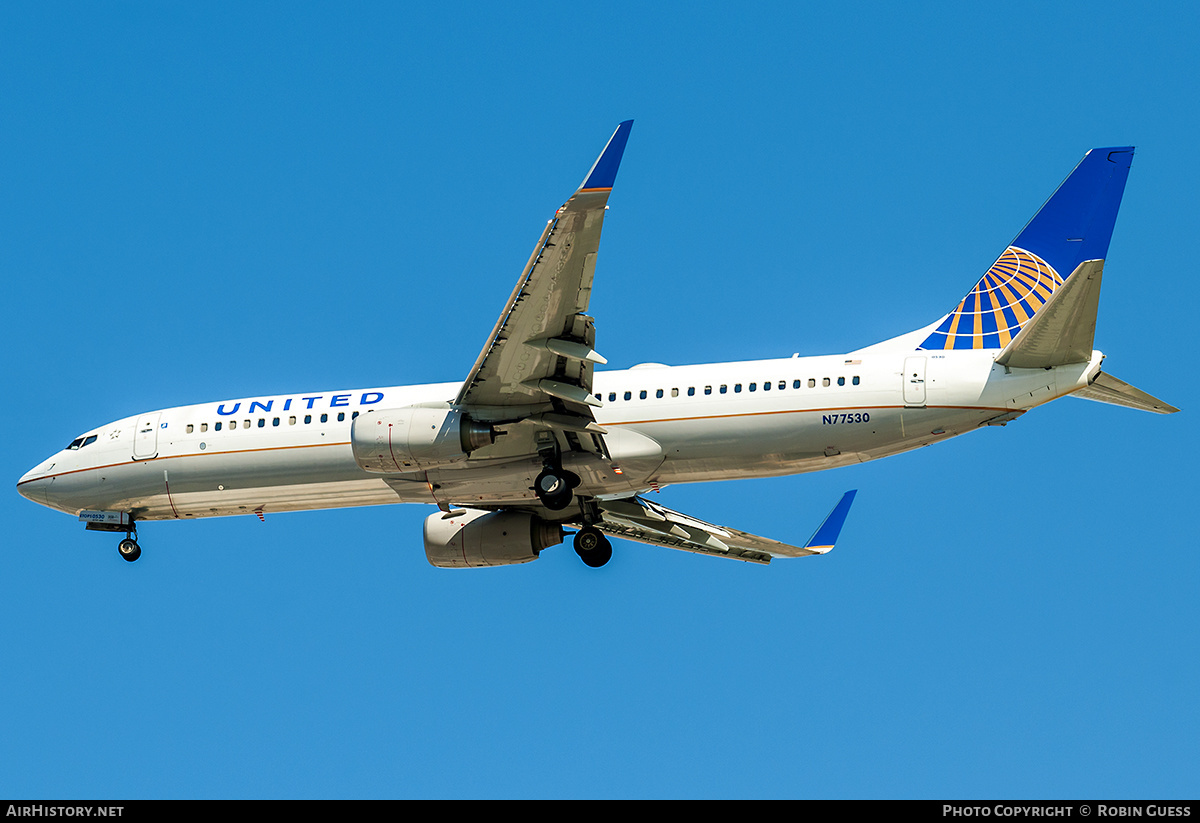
[17,120,1178,569]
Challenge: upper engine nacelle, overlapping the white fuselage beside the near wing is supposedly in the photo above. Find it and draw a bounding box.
[350,406,496,474]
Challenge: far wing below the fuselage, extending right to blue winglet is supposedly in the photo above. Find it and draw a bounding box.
[595,492,857,564]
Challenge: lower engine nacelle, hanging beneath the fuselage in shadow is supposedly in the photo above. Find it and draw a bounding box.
[425,509,563,569]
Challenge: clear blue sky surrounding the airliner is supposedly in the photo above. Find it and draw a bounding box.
[0,2,1200,798]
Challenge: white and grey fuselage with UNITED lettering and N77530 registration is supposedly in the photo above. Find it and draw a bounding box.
[11,346,1102,519]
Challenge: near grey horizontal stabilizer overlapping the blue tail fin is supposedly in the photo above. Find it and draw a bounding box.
[996,260,1104,368]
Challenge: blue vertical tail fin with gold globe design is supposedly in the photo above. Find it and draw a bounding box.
[918,146,1133,349]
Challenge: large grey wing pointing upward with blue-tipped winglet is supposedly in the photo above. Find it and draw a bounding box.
[455,120,634,451]
